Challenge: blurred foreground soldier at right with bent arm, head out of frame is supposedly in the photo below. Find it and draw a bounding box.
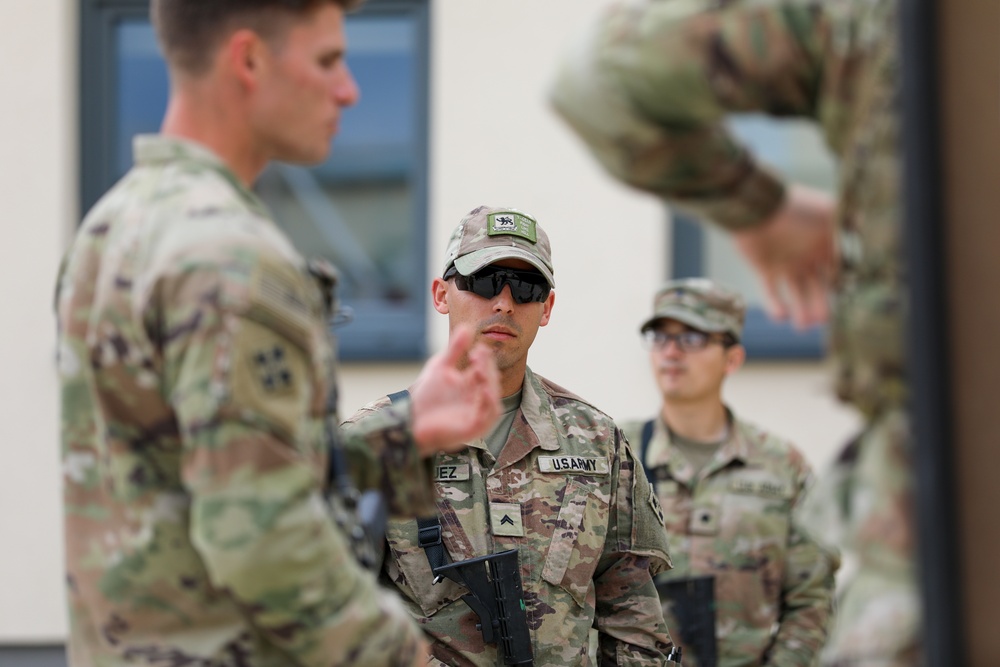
[552,0,920,666]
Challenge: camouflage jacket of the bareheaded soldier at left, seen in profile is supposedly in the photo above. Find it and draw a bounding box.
[57,137,433,667]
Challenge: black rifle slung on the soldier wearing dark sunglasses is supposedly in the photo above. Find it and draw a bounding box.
[434,549,534,665]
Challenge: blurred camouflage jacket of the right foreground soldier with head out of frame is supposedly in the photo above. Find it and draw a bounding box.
[552,0,905,414]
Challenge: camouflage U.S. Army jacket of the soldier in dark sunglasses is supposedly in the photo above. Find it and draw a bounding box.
[340,369,670,667]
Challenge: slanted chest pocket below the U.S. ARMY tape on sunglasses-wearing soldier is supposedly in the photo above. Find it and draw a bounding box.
[542,480,609,606]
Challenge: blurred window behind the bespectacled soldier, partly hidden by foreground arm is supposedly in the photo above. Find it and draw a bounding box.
[670,114,836,359]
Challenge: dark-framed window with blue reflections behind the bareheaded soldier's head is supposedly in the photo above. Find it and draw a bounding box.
[80,0,429,360]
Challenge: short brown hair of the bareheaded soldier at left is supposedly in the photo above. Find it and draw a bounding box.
[149,0,365,75]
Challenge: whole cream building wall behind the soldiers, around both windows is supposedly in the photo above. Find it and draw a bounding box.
[0,0,856,645]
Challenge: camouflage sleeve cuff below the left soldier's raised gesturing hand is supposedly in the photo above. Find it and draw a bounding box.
[340,398,437,518]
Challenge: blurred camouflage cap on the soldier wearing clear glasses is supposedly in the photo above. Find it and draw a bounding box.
[639,278,747,340]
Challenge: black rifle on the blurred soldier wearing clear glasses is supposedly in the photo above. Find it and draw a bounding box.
[656,575,719,667]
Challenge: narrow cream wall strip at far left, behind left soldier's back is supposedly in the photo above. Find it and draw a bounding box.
[0,0,78,643]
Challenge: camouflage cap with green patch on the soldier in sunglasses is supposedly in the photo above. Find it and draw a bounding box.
[444,206,556,287]
